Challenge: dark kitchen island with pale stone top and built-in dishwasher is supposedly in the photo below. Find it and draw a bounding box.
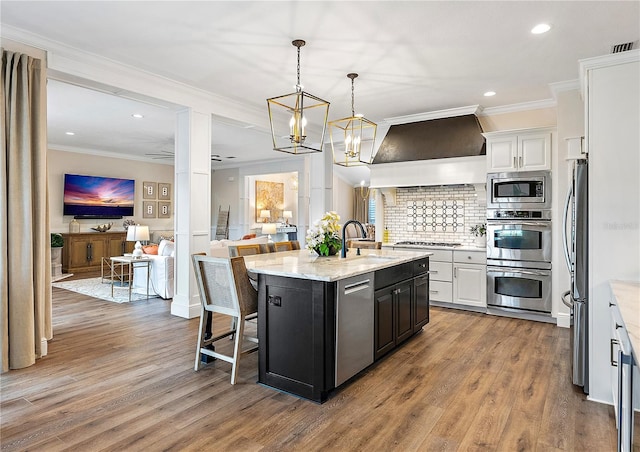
[245,250,431,403]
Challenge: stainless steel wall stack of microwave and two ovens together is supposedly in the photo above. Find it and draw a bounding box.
[487,171,551,316]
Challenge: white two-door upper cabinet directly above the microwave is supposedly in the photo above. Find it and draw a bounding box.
[483,129,551,173]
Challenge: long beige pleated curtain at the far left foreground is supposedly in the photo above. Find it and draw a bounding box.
[0,48,53,372]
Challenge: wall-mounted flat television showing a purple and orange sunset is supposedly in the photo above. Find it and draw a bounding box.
[63,174,135,218]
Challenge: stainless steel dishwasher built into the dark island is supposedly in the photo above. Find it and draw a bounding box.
[336,272,374,387]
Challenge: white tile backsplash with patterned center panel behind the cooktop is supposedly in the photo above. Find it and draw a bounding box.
[384,185,487,246]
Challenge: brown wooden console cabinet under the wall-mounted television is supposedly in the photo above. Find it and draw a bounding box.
[62,231,134,273]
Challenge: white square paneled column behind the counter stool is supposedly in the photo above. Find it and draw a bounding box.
[171,108,211,319]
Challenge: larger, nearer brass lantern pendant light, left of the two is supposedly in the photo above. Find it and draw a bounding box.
[267,39,329,154]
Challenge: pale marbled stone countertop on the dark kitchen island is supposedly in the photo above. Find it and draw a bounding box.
[244,249,432,281]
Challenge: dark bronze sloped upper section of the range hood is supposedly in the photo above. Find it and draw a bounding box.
[373,114,486,165]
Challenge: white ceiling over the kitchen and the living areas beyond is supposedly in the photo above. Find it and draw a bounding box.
[0,0,640,184]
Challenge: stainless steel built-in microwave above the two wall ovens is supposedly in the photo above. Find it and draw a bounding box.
[487,171,551,209]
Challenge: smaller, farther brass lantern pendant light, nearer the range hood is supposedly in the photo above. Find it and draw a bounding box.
[329,73,378,166]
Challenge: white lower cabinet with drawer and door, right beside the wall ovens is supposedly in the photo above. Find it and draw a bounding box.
[453,251,487,308]
